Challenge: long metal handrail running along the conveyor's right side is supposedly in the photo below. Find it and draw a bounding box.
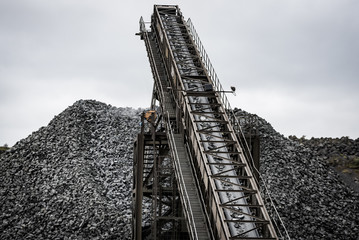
[186,19,290,239]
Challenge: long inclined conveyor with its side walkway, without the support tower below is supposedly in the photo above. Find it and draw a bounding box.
[134,5,277,239]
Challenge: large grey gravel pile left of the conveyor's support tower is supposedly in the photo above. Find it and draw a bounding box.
[0,101,140,239]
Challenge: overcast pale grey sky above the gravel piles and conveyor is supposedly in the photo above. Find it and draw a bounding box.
[0,0,359,146]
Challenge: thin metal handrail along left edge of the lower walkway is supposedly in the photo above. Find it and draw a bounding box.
[165,111,198,239]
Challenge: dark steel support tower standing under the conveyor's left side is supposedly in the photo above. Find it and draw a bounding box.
[133,118,188,239]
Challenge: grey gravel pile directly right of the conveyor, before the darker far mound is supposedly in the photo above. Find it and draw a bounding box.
[237,110,359,239]
